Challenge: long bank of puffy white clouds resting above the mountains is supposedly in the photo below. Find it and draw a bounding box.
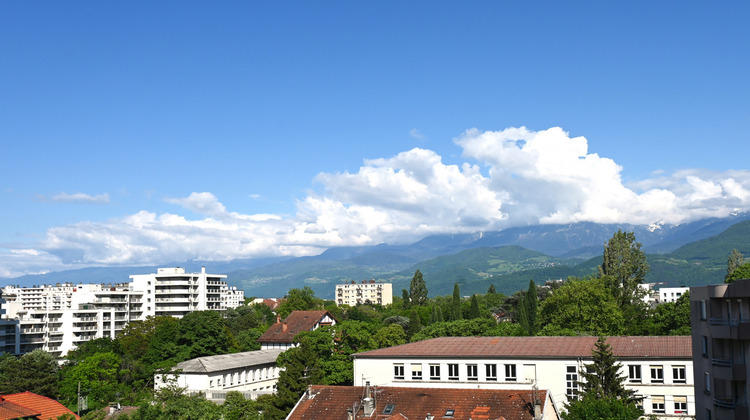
[0,127,750,276]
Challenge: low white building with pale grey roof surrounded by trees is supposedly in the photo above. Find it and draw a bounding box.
[154,349,283,400]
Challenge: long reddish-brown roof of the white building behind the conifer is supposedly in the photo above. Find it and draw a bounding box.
[352,336,693,359]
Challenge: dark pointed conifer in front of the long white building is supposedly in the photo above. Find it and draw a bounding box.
[580,336,635,402]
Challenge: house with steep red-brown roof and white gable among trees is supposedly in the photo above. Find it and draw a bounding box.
[258,311,336,350]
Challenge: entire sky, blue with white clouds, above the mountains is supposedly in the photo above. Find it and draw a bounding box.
[0,1,750,277]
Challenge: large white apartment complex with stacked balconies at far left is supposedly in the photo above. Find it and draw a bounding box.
[0,268,244,357]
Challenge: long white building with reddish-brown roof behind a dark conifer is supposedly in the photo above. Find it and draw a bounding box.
[352,336,695,418]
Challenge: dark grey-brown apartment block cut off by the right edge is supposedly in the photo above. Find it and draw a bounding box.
[690,279,750,420]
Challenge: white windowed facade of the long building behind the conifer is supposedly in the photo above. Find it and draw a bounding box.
[353,337,695,419]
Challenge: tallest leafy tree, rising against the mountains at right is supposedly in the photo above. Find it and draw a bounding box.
[599,229,649,306]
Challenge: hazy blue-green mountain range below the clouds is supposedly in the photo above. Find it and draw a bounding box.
[2,213,750,298]
